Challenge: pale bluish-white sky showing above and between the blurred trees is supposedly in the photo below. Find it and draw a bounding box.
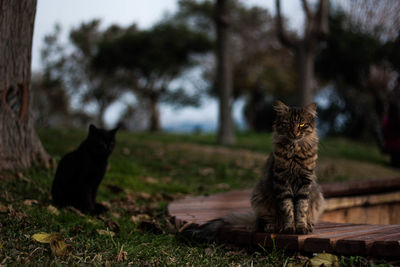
[32,0,303,131]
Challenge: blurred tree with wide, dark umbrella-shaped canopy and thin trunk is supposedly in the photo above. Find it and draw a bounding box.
[92,21,210,131]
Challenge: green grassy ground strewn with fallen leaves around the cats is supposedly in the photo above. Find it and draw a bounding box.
[0,129,400,266]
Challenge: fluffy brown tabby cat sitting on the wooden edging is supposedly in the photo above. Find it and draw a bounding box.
[184,101,324,241]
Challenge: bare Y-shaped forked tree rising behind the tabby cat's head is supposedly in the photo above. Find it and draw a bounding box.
[275,0,329,105]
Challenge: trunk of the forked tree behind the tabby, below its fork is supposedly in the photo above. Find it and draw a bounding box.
[296,44,315,106]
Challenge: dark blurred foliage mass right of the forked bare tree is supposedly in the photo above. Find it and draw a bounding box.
[315,7,400,139]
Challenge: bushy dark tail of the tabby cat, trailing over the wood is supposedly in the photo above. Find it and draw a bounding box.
[181,211,257,243]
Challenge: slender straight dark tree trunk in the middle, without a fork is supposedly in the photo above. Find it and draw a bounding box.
[216,0,235,145]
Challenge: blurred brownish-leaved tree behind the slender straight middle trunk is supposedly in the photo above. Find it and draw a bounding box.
[176,0,297,131]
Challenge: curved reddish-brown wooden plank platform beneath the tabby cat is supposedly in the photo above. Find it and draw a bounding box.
[168,184,400,257]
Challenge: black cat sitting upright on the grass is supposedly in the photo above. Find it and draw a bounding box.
[51,124,118,214]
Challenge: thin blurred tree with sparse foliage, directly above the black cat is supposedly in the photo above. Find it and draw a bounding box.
[67,20,126,128]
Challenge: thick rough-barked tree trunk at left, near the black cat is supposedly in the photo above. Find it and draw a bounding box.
[0,0,51,170]
